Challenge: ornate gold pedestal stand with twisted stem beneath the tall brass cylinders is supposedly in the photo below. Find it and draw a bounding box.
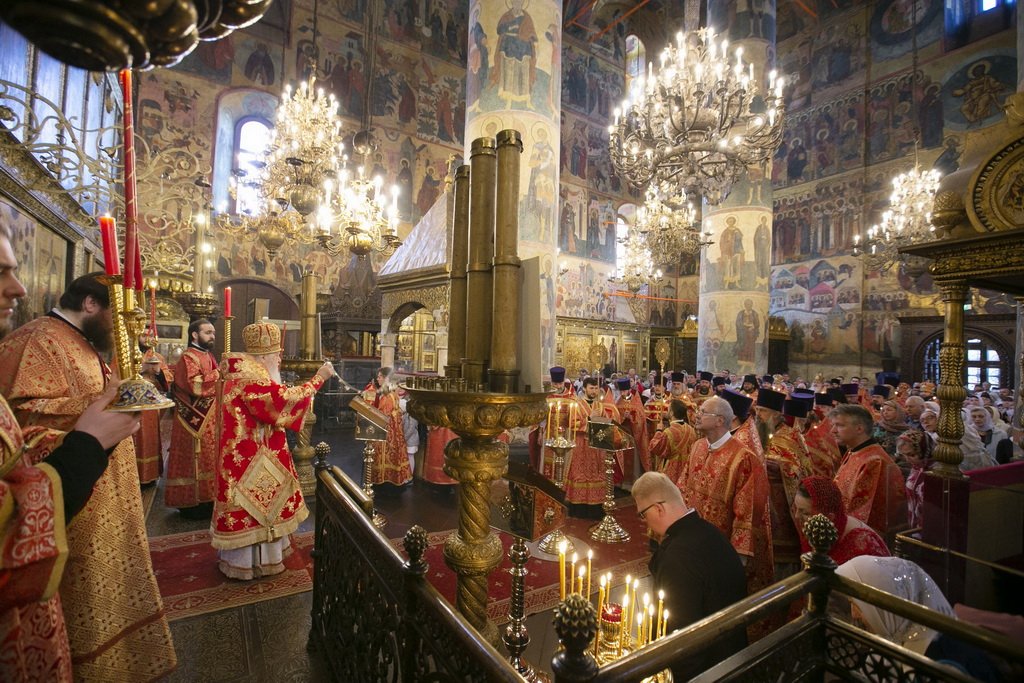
[403,385,548,643]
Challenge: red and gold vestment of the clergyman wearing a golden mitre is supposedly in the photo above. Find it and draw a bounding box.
[211,353,324,550]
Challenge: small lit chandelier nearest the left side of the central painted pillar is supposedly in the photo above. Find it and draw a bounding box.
[316,157,401,258]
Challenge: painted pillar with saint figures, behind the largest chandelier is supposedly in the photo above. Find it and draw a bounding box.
[700,0,775,375]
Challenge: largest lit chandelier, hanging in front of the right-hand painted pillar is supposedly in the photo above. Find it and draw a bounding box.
[608,28,783,204]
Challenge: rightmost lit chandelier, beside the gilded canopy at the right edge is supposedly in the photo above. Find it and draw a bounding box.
[853,164,941,270]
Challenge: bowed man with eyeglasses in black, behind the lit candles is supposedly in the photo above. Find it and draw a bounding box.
[632,472,746,681]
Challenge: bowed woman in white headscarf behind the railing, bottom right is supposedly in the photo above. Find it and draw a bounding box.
[836,555,999,681]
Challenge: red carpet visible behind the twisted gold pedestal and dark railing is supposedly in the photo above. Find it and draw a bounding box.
[392,506,650,624]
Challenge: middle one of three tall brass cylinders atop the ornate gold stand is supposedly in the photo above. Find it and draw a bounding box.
[462,137,497,387]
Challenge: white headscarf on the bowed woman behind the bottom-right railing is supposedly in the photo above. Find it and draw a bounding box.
[836,555,955,654]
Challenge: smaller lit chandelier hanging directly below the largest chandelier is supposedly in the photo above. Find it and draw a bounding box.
[635,185,712,268]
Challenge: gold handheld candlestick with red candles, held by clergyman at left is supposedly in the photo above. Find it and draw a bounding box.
[97,275,174,413]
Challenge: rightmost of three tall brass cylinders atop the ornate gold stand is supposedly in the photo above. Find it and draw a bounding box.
[487,130,522,393]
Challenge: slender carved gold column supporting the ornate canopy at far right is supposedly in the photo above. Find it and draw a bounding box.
[934,281,968,477]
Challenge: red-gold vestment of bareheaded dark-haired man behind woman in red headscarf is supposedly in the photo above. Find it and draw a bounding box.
[836,440,907,538]
